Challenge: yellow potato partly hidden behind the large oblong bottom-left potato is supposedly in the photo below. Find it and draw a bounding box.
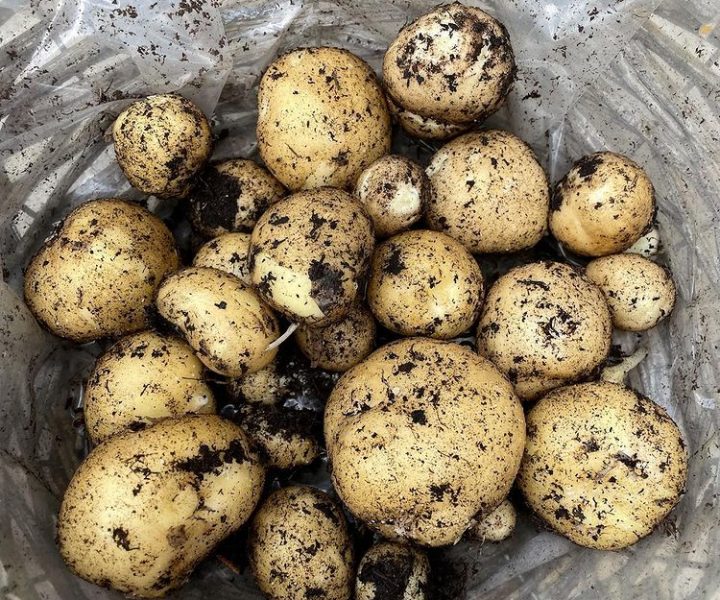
[83,331,215,444]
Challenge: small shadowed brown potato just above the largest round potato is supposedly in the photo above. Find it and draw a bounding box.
[295,305,377,372]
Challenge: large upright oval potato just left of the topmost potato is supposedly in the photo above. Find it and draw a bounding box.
[257,48,391,190]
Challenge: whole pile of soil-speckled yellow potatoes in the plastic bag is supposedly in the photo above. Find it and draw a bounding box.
[25,3,687,600]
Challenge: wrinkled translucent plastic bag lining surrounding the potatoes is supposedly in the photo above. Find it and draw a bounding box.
[0,0,720,600]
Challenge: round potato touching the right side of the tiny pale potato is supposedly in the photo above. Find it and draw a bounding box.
[426,130,550,253]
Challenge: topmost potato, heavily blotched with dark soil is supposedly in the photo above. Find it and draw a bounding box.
[383,2,515,123]
